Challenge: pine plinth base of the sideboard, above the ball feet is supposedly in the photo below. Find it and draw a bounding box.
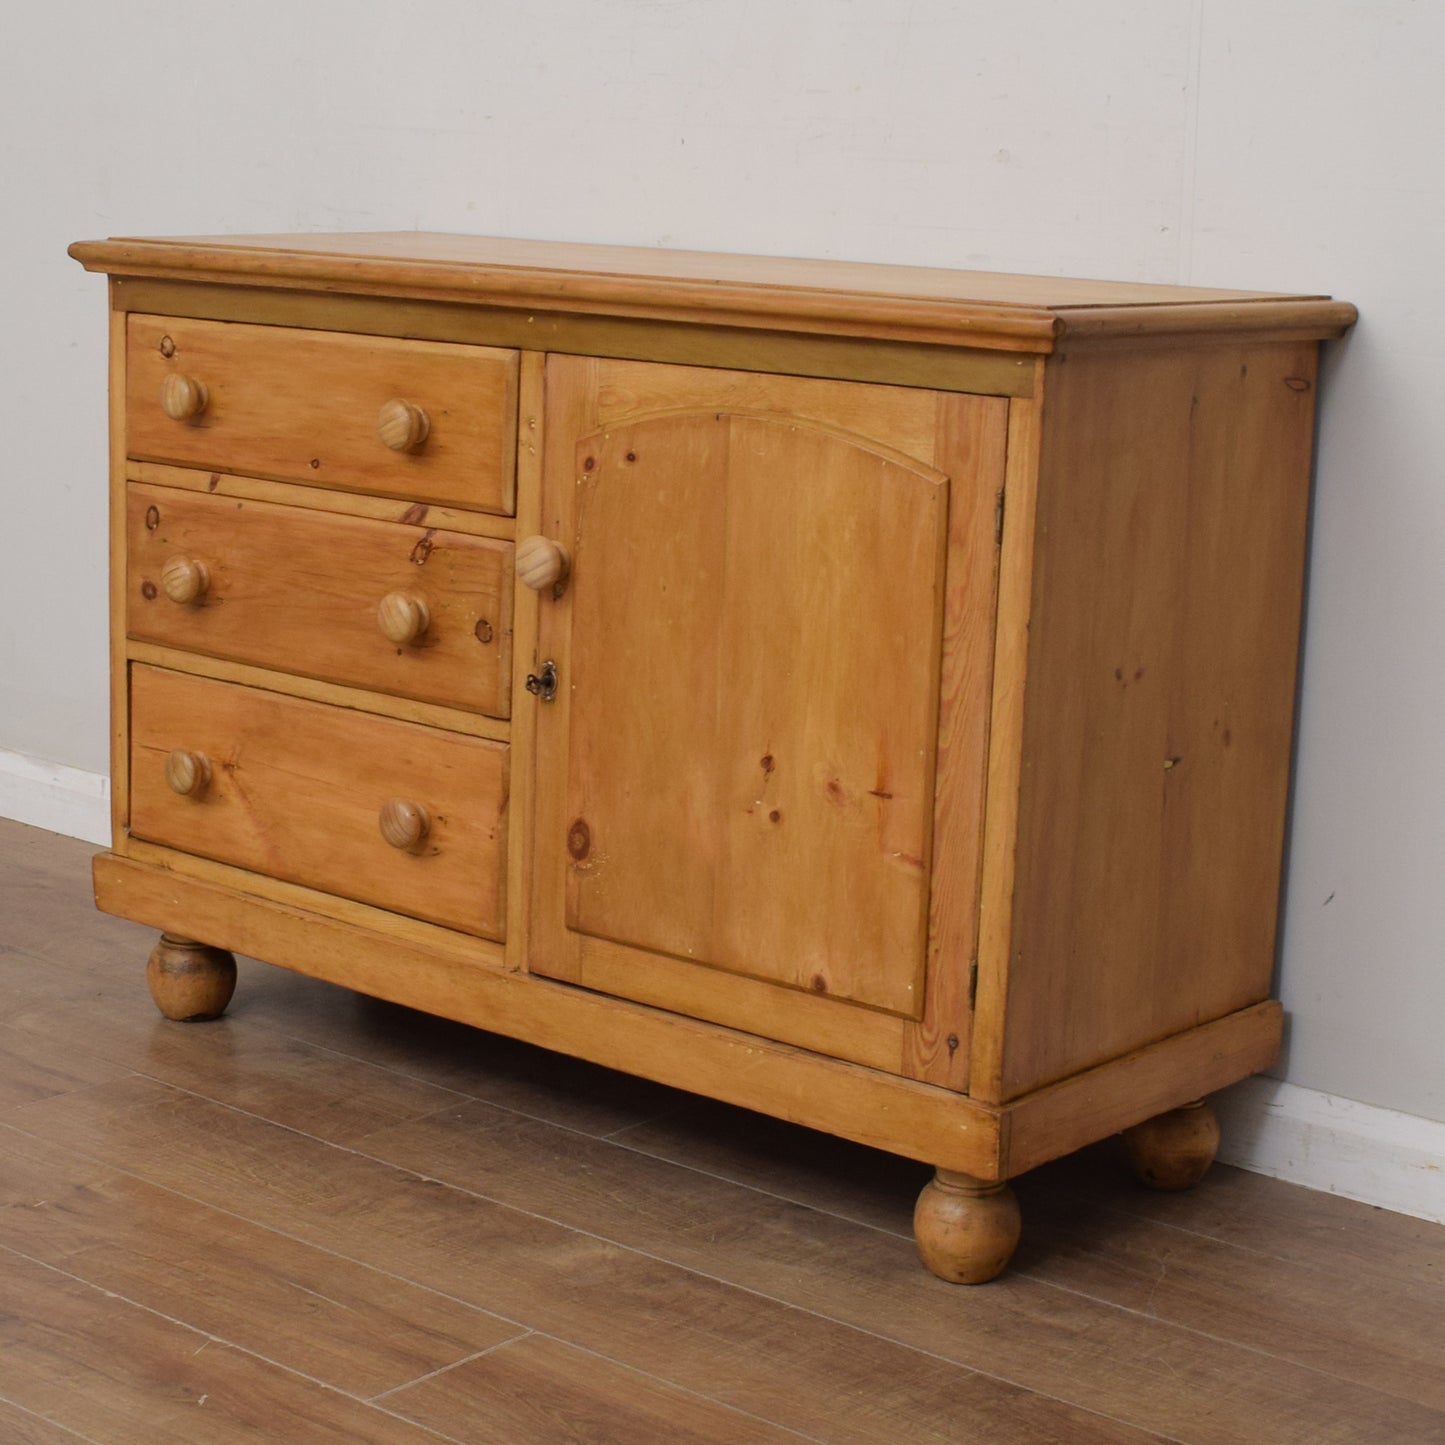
[95,857,1279,1178]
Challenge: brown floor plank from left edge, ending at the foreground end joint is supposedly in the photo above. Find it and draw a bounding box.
[0,1127,520,1397]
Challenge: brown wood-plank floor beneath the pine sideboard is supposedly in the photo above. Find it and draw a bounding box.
[0,822,1445,1445]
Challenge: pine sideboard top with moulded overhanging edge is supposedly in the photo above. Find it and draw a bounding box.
[71,231,1355,353]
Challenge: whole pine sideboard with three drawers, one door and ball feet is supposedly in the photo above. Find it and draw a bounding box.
[71,234,1354,1282]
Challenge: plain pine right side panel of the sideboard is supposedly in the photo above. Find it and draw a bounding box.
[972,342,1318,1101]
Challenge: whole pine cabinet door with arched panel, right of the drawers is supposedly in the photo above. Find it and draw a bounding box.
[533,357,1007,1086]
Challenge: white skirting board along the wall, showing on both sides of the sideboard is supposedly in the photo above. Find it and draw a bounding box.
[0,750,1445,1222]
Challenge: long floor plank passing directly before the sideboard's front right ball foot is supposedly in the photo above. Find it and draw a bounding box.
[346,1104,1445,1445]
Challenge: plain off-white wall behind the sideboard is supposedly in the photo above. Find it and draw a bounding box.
[0,0,1445,1120]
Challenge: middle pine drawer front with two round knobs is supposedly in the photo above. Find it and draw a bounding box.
[126,483,512,717]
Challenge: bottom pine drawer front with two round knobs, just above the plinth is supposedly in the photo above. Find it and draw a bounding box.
[130,665,507,938]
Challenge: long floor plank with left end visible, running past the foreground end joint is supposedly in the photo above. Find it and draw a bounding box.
[6,1078,1156,1445]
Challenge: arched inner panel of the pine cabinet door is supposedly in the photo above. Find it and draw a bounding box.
[557,413,948,1032]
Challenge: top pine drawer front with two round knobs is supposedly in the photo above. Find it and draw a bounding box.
[126,315,517,513]
